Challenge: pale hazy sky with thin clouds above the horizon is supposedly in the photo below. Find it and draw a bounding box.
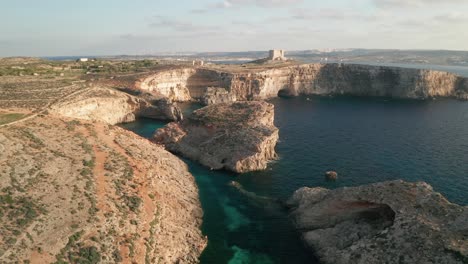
[0,0,468,57]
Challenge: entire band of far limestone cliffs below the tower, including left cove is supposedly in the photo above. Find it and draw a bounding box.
[136,64,468,101]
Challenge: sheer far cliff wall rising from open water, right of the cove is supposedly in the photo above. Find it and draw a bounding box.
[230,64,468,100]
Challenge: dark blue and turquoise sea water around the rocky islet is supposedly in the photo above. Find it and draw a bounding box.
[119,97,468,263]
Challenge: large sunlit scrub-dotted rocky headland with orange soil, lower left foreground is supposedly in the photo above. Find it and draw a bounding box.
[0,116,206,263]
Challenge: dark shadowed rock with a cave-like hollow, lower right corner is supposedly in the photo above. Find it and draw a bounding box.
[288,181,468,264]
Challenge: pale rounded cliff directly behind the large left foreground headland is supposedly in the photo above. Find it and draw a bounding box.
[50,87,181,124]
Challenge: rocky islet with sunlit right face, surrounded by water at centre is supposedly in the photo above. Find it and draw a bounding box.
[154,102,278,173]
